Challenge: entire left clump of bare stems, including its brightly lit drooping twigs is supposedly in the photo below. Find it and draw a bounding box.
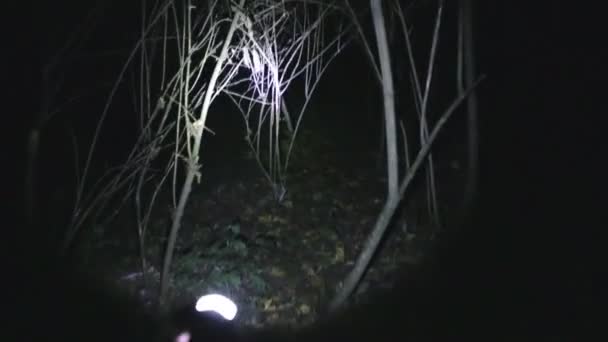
[63,0,350,305]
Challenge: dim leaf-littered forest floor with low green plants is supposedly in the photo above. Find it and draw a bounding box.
[76,108,462,326]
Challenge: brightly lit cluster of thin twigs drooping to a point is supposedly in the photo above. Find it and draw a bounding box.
[228,0,346,202]
